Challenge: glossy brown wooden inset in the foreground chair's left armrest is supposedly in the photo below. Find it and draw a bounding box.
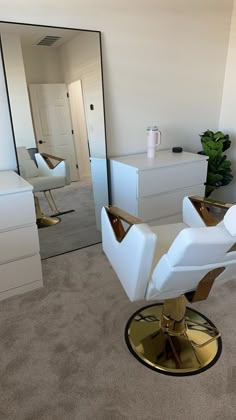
[105,206,143,242]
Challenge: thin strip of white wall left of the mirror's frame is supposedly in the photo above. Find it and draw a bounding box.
[0,56,16,171]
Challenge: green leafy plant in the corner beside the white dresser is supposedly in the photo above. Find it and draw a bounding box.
[200,130,233,197]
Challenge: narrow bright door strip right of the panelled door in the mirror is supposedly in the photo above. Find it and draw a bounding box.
[68,80,91,179]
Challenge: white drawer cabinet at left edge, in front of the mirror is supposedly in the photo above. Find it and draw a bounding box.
[0,171,43,300]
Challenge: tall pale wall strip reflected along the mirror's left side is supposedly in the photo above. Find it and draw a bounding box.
[1,33,35,148]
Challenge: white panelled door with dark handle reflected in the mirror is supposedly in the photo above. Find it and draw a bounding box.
[29,83,78,181]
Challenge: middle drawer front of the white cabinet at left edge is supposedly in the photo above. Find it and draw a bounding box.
[0,224,39,264]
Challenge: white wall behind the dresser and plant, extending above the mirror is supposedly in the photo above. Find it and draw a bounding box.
[1,0,232,167]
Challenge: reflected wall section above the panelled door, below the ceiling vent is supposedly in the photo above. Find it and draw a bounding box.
[22,47,64,84]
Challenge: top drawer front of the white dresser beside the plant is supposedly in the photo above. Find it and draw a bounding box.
[137,160,207,197]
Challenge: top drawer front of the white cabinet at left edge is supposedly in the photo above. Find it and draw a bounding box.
[0,191,36,230]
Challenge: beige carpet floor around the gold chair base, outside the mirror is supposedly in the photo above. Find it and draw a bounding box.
[0,245,236,420]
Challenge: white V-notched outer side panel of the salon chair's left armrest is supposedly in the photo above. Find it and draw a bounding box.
[102,208,156,301]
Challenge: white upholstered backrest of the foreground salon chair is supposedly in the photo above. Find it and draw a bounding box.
[146,205,236,299]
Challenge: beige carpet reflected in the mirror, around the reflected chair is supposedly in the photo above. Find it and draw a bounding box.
[37,179,101,259]
